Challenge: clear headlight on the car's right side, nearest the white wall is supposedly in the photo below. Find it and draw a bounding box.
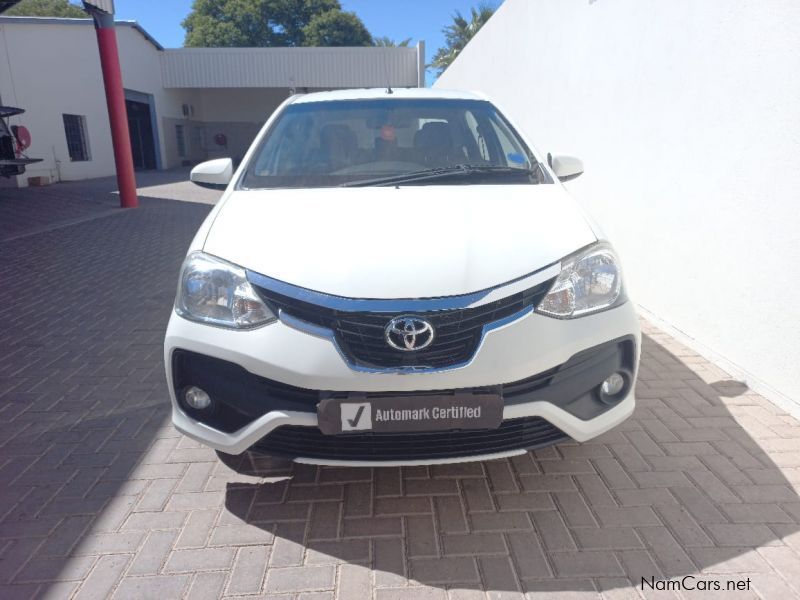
[536,242,626,319]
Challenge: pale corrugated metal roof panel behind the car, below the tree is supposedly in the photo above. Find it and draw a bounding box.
[162,47,419,88]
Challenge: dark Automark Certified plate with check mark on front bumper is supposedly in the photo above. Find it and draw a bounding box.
[317,393,503,435]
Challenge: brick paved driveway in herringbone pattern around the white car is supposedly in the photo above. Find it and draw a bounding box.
[0,176,800,600]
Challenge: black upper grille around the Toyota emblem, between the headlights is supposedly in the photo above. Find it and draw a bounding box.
[254,279,553,368]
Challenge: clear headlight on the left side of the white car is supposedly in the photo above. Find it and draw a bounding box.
[175,252,275,329]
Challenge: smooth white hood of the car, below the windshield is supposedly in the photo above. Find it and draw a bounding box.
[203,184,596,298]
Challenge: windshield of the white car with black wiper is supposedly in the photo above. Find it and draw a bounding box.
[242,98,545,189]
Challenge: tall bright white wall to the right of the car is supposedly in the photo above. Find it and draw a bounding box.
[437,0,800,403]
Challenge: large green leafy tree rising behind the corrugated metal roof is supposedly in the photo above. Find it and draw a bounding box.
[183,0,371,48]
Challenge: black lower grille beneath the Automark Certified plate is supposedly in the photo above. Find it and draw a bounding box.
[253,417,568,461]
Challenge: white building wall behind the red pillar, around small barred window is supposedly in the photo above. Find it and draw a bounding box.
[0,22,186,184]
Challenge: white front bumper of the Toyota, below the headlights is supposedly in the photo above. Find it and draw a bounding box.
[165,302,640,465]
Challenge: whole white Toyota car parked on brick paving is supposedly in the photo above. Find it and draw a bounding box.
[164,89,640,465]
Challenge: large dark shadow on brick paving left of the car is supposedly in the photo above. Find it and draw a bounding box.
[0,198,208,598]
